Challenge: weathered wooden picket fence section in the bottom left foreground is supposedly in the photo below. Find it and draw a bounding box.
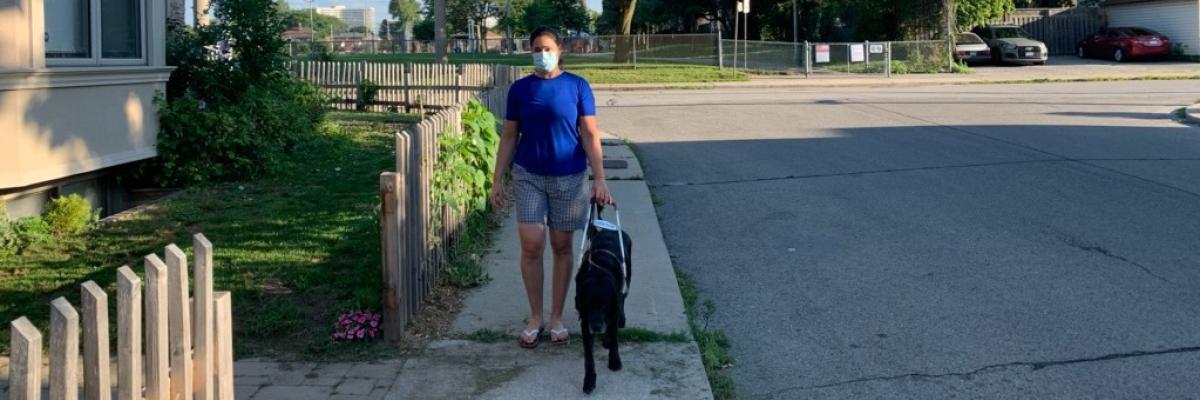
[8,234,234,400]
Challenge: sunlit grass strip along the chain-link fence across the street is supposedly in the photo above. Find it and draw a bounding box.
[324,53,750,84]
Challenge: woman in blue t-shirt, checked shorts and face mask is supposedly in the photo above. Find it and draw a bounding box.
[491,28,613,348]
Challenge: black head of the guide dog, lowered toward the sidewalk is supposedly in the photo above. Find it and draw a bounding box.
[575,251,620,333]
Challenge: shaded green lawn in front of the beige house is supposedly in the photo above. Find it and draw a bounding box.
[0,113,407,359]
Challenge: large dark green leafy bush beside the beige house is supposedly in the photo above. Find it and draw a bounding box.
[154,0,325,186]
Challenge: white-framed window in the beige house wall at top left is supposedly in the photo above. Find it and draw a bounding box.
[44,0,145,66]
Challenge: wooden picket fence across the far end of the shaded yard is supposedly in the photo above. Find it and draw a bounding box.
[292,61,517,113]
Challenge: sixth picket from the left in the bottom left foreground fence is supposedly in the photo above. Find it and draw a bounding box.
[167,244,193,400]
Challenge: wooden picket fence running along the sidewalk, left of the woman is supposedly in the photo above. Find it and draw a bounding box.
[379,73,517,342]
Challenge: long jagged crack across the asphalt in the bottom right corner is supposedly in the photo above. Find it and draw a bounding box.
[750,346,1200,399]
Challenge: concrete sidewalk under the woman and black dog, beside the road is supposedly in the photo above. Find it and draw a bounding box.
[224,138,713,400]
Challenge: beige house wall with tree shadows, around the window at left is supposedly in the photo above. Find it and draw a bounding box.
[0,0,173,216]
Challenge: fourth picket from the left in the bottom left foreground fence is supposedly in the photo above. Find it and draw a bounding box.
[116,265,143,400]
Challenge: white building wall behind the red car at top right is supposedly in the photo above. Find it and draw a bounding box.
[1104,0,1200,55]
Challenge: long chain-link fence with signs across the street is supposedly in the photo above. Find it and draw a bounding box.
[288,34,952,76]
